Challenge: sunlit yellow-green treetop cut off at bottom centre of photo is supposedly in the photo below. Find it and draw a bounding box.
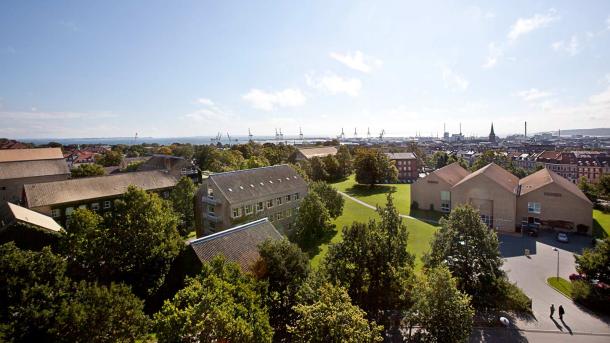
[288,283,383,343]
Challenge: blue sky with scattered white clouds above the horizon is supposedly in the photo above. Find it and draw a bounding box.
[0,0,610,139]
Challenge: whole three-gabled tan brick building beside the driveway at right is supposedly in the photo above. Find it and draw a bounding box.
[411,163,593,234]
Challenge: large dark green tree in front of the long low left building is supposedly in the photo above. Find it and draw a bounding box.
[64,186,184,297]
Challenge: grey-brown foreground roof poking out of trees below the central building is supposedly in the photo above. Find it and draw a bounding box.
[191,218,283,271]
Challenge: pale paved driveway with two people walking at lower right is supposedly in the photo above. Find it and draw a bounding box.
[500,234,610,341]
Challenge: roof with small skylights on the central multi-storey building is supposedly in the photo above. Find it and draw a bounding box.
[208,164,307,203]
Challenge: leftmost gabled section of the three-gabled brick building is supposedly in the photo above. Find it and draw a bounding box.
[411,162,470,213]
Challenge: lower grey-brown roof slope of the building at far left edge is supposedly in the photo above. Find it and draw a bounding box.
[0,158,70,180]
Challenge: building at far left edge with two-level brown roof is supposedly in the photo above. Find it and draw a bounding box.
[0,148,70,204]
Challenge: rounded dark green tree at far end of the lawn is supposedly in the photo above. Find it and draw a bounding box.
[354,149,398,186]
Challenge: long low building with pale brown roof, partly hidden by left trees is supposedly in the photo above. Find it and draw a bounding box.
[23,171,178,227]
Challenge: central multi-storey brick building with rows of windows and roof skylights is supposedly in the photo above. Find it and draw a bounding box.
[195,165,307,237]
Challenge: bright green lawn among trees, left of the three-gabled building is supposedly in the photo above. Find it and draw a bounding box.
[310,175,437,269]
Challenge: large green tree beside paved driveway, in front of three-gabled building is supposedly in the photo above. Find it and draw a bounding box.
[424,205,505,304]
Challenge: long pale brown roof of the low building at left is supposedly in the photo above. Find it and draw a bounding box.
[24,171,177,208]
